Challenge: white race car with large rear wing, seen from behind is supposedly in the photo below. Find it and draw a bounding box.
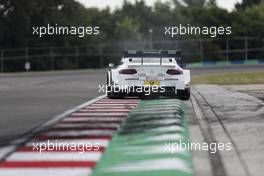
[107,50,190,100]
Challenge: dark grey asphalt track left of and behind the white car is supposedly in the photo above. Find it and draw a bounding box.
[0,65,264,145]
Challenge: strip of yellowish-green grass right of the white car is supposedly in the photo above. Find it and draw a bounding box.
[192,72,264,85]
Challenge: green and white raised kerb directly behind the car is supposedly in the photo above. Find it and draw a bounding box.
[93,99,193,176]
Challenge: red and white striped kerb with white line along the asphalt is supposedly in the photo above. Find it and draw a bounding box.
[0,95,140,176]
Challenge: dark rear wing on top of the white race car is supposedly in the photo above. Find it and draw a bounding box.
[123,50,181,60]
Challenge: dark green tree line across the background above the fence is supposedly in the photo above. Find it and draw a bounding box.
[0,0,264,48]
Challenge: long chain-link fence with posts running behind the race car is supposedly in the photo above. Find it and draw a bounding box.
[0,37,264,72]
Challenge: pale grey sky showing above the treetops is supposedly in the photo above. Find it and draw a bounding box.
[77,0,241,10]
